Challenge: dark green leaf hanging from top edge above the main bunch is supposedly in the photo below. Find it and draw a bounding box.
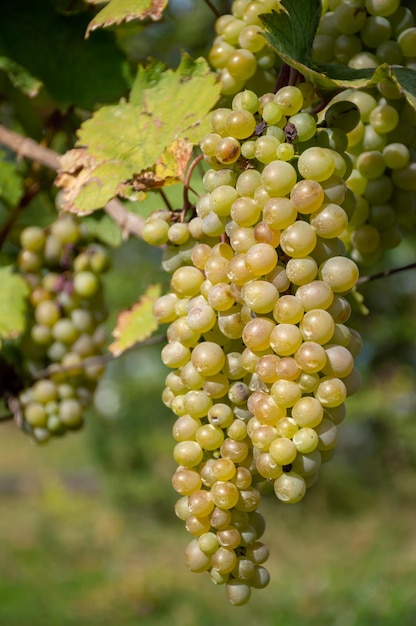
[260,0,322,66]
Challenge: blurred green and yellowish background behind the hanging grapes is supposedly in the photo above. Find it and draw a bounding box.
[0,0,416,626]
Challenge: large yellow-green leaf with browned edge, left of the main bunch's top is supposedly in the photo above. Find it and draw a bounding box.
[57,56,220,214]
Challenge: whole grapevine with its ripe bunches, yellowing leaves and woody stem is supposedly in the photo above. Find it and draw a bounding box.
[0,0,416,605]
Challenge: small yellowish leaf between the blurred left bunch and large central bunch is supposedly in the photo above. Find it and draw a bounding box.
[108,284,161,356]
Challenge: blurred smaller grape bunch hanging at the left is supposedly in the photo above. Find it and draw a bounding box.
[17,215,109,443]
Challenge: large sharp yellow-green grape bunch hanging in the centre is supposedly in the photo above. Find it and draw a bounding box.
[143,86,361,604]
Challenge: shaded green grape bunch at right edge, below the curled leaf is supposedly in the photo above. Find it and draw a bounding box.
[332,90,416,264]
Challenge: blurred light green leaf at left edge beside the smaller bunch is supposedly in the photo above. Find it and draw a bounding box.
[0,265,29,339]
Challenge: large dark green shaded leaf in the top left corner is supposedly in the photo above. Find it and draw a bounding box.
[0,0,127,110]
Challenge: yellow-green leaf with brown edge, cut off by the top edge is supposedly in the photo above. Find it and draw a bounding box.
[86,0,167,37]
